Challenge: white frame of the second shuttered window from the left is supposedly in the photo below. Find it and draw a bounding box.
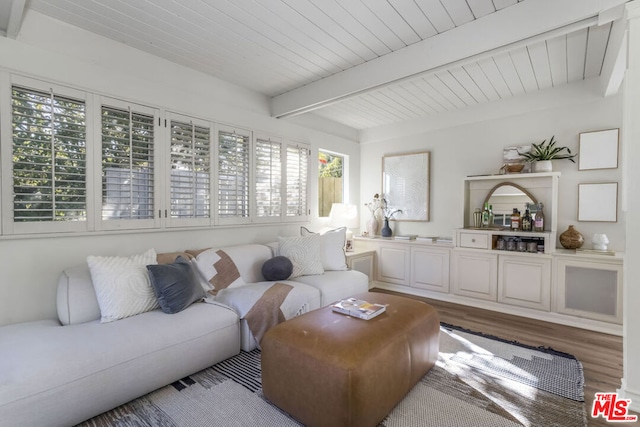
[93,97,161,230]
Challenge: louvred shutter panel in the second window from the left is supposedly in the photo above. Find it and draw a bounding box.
[102,106,155,227]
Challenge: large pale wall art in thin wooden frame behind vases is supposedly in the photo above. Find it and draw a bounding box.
[382,151,430,221]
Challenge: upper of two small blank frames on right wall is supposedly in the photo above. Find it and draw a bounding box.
[578,129,620,170]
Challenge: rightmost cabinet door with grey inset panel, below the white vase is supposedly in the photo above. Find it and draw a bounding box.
[555,258,622,323]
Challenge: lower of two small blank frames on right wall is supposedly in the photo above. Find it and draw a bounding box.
[578,182,618,222]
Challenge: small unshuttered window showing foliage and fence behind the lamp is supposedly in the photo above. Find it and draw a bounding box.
[318,151,344,217]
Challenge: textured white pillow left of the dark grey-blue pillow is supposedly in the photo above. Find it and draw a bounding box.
[87,249,158,323]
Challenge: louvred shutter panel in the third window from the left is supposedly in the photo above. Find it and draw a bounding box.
[170,119,211,225]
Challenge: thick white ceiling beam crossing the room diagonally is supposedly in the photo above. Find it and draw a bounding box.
[271,0,627,118]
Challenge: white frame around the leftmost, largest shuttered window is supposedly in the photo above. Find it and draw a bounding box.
[0,72,94,235]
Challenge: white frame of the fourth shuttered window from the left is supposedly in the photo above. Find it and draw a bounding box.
[214,125,255,225]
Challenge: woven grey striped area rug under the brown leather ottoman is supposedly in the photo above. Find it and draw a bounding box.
[75,325,586,427]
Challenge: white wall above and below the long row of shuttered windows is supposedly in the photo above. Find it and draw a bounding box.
[0,8,360,325]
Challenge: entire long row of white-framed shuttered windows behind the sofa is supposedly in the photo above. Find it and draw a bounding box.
[0,72,310,235]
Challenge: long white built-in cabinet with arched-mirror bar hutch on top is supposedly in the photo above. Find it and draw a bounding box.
[356,172,623,335]
